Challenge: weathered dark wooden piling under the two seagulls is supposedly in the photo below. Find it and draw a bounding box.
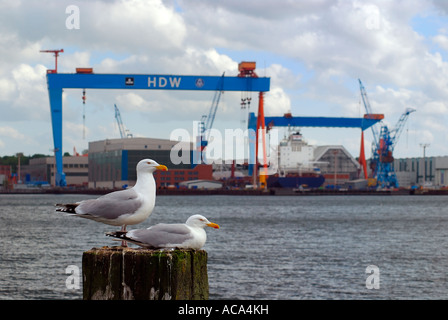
[82,247,209,300]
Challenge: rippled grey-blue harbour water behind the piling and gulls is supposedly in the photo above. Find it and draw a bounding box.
[0,195,448,300]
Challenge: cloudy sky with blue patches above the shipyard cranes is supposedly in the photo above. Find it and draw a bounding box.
[0,0,448,158]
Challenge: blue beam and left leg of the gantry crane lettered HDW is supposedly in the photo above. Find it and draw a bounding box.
[47,56,270,186]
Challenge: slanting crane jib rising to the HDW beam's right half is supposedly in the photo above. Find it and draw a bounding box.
[198,72,225,163]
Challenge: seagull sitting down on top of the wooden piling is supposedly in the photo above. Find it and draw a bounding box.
[106,214,219,250]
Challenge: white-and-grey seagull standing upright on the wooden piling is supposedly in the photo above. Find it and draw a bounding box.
[56,159,168,245]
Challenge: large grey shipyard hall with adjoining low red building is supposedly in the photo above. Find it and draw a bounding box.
[88,138,213,189]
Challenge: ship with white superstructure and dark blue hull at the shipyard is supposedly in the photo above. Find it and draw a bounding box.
[267,131,325,189]
